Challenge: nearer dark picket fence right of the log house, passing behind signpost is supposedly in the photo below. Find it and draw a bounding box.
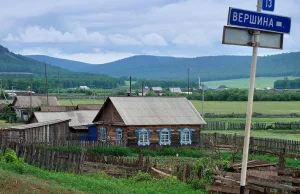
[200,133,300,153]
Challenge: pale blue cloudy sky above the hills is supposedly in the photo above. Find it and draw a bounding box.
[0,0,300,64]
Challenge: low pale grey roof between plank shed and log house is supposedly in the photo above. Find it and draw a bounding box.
[33,110,98,127]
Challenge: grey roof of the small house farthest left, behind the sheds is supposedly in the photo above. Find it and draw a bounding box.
[12,96,59,108]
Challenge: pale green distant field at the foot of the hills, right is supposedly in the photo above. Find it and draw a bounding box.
[204,77,297,89]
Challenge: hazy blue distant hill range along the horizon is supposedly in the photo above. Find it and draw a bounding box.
[25,52,300,81]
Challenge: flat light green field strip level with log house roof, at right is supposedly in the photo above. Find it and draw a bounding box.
[192,100,300,114]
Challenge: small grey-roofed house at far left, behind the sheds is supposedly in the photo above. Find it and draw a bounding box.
[12,96,59,121]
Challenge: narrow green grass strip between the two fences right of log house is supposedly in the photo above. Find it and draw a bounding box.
[201,130,300,141]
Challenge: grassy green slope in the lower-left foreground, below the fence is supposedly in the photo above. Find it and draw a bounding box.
[0,163,200,194]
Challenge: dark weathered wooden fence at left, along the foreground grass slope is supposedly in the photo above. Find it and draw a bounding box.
[1,142,85,174]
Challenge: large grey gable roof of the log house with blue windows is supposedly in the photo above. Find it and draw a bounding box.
[94,97,206,125]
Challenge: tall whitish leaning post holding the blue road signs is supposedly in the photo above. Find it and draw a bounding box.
[240,0,262,194]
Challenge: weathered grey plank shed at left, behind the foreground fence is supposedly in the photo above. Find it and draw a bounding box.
[7,119,70,143]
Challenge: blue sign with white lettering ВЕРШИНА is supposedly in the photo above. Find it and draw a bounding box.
[227,7,291,34]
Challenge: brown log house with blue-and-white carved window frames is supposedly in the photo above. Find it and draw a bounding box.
[93,97,206,146]
